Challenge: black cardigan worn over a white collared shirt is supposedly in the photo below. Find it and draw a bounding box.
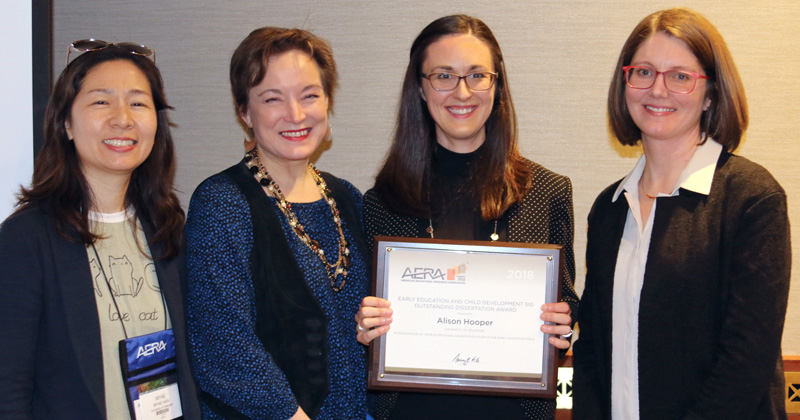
[573,152,791,420]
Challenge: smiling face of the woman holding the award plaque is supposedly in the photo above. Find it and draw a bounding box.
[421,34,496,153]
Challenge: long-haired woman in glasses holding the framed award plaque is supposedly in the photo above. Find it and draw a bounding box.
[356,15,578,419]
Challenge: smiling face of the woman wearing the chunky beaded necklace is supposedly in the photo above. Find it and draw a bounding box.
[241,50,328,167]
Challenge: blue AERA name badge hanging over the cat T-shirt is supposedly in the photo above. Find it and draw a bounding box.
[119,329,183,420]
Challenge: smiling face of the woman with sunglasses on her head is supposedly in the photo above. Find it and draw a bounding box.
[65,60,158,182]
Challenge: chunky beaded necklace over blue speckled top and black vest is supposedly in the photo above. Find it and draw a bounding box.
[244,148,350,292]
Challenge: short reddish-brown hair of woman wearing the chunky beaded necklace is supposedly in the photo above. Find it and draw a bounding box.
[230,26,338,118]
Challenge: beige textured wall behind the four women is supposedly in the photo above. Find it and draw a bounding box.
[53,0,800,355]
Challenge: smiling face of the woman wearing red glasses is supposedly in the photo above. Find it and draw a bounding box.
[625,32,711,144]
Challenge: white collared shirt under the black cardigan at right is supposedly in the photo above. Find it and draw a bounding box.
[611,139,722,420]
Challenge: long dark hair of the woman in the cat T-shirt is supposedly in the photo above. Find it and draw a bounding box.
[14,45,185,258]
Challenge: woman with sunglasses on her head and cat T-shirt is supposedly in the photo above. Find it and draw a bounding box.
[0,40,200,420]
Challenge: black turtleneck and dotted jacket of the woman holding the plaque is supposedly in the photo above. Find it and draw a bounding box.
[364,147,578,420]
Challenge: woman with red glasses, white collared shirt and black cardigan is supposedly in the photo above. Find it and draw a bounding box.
[573,8,791,420]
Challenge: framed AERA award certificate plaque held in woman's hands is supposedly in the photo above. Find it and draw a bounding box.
[369,237,561,397]
